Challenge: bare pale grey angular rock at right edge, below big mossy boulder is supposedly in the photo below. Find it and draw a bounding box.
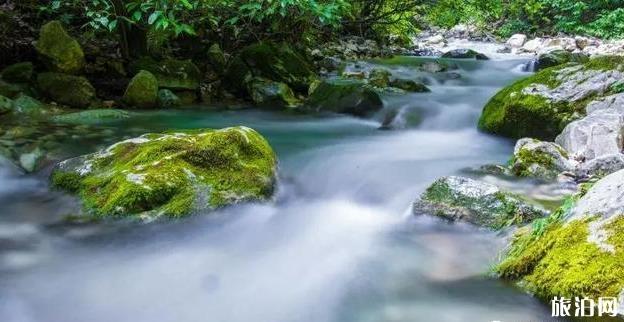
[555,110,624,161]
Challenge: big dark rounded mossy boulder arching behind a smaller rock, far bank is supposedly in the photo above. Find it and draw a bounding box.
[224,43,316,95]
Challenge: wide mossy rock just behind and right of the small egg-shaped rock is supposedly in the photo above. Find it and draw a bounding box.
[130,57,202,90]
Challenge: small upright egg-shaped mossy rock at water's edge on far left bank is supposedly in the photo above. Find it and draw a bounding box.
[123,70,158,108]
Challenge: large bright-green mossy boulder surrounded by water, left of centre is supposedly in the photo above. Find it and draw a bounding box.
[51,127,277,217]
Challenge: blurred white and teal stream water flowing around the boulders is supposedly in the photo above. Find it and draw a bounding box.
[0,58,564,322]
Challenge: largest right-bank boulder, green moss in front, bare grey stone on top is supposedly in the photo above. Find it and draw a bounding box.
[479,56,624,141]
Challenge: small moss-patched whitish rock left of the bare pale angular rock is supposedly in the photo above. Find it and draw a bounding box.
[509,138,575,180]
